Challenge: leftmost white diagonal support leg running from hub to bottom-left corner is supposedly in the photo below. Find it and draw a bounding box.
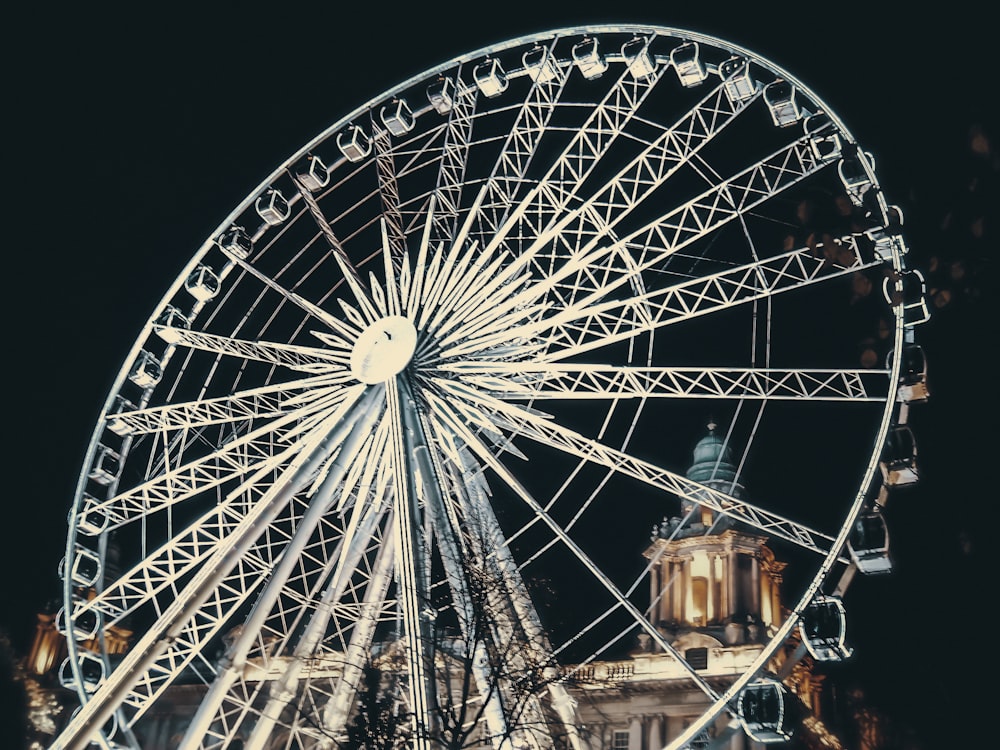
[51,389,382,750]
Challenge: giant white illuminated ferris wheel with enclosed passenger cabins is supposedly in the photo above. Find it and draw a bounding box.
[54,26,926,748]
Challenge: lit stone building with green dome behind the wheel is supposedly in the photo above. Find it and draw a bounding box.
[576,422,841,750]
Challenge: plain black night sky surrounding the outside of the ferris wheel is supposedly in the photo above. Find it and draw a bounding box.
[0,0,1000,749]
